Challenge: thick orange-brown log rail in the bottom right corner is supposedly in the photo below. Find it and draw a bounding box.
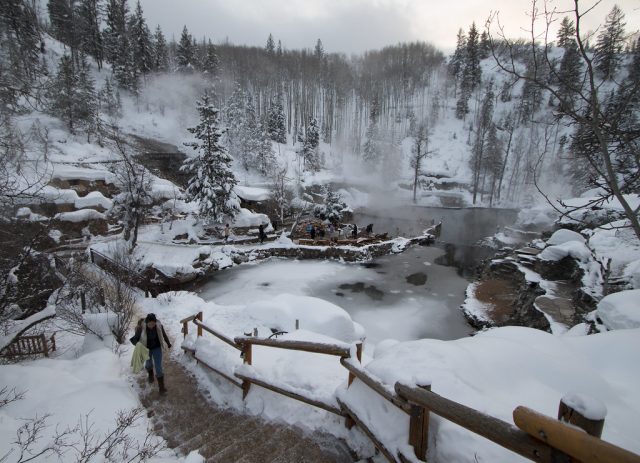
[513,406,640,463]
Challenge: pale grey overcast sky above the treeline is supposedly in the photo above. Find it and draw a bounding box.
[140,0,640,53]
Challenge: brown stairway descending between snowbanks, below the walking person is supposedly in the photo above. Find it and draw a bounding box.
[139,359,353,463]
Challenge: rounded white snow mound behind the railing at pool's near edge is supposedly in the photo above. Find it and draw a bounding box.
[246,294,357,342]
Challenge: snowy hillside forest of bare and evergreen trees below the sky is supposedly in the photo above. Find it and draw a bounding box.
[0,0,640,221]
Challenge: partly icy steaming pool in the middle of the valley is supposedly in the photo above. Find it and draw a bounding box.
[199,207,516,344]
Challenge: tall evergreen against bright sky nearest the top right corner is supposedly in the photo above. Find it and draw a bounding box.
[593,5,625,79]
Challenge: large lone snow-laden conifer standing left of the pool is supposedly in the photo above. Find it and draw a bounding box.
[181,93,240,222]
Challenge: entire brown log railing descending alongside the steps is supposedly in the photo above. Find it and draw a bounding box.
[180,312,640,463]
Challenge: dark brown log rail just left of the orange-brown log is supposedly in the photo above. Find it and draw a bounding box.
[395,383,563,461]
